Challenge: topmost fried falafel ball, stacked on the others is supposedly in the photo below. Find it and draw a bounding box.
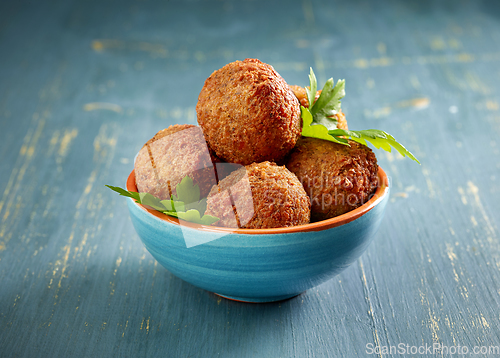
[196,59,302,165]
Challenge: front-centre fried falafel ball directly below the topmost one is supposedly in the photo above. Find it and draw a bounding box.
[205,162,311,229]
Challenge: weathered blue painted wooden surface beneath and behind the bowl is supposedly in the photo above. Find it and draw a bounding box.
[0,0,500,357]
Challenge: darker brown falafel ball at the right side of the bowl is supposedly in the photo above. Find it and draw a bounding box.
[286,138,378,221]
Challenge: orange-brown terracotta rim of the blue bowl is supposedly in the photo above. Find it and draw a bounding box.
[126,166,390,235]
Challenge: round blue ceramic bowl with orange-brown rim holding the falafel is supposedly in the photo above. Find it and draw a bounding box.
[127,168,390,302]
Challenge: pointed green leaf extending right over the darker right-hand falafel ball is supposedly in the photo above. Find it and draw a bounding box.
[328,128,420,164]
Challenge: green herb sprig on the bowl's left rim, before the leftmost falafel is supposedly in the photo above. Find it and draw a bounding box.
[106,175,219,225]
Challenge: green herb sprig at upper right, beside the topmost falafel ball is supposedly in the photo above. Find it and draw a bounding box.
[300,68,420,164]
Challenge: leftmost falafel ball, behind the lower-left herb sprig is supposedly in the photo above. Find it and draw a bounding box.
[134,124,220,199]
